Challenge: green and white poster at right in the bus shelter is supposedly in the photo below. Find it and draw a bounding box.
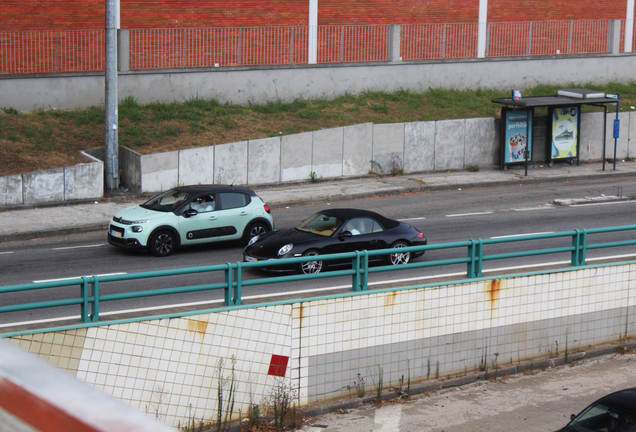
[550,106,580,159]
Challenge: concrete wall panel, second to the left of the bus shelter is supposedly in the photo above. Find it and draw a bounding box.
[435,120,466,170]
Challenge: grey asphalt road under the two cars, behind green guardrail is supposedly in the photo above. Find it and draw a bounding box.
[0,179,636,330]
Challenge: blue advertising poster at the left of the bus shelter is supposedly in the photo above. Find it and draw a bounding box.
[503,109,533,164]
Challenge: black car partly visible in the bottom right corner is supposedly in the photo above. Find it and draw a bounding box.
[557,388,636,432]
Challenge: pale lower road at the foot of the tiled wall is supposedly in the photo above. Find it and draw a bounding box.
[306,354,636,432]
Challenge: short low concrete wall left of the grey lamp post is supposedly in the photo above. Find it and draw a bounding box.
[0,152,104,207]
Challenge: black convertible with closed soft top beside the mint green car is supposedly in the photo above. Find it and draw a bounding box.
[243,209,426,274]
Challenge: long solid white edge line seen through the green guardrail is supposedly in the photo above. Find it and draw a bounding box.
[7,254,636,328]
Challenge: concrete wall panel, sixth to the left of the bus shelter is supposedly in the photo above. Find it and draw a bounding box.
[314,128,344,178]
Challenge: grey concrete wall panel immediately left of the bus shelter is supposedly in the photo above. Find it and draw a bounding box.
[464,118,499,168]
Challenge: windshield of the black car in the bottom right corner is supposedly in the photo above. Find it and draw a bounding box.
[566,404,636,432]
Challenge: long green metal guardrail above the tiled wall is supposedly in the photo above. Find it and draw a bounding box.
[0,225,636,323]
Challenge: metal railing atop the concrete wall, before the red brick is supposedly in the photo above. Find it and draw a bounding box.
[0,20,636,74]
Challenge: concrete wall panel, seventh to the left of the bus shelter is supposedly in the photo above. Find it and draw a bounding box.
[280,132,313,182]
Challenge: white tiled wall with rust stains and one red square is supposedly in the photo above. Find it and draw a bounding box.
[6,264,636,426]
